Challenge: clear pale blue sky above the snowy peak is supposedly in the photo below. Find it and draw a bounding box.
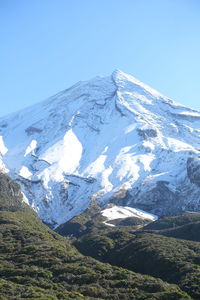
[0,0,200,116]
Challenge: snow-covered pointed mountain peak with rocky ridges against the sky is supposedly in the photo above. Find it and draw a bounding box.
[0,70,200,226]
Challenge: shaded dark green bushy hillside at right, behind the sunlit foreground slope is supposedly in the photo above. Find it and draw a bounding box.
[75,214,200,299]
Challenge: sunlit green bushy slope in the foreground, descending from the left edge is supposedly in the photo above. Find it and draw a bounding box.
[0,174,191,300]
